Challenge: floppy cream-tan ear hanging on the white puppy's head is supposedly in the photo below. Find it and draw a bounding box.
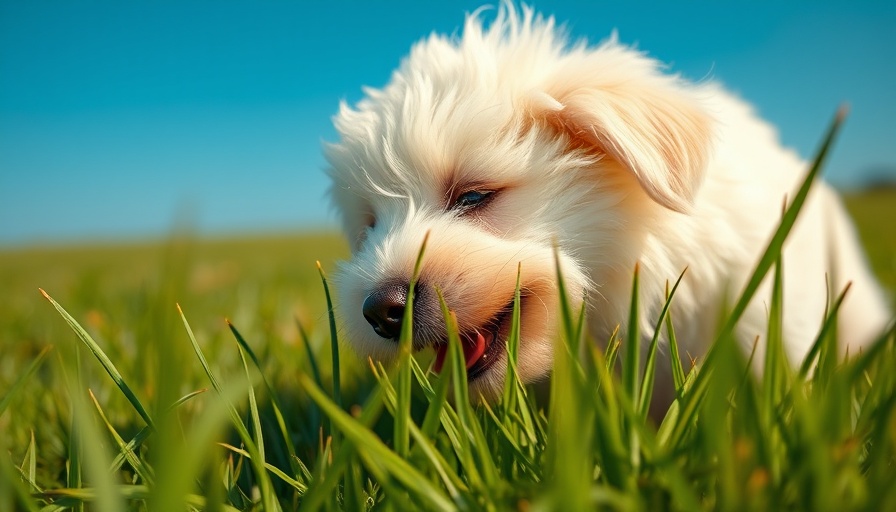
[531,77,712,212]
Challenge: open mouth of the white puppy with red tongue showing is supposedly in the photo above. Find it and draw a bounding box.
[433,299,513,380]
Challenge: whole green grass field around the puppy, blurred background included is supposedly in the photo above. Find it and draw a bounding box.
[0,114,896,511]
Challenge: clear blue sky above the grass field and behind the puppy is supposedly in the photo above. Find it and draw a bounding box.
[0,0,896,246]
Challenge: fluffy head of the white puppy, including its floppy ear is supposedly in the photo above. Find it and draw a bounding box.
[327,5,711,397]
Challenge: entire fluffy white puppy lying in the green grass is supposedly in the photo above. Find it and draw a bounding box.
[327,4,890,404]
